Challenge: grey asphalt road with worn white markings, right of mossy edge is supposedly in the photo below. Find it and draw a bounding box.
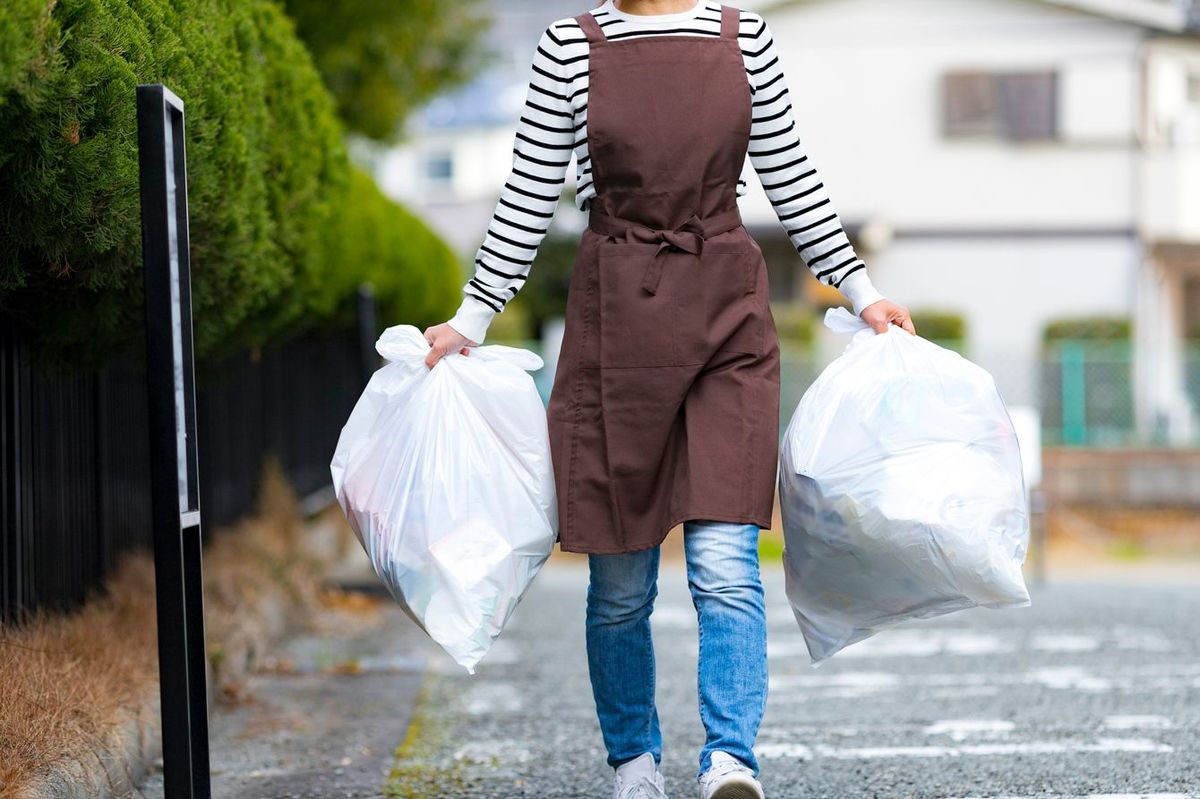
[389,561,1200,799]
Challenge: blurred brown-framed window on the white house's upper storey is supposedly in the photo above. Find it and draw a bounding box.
[942,71,1058,142]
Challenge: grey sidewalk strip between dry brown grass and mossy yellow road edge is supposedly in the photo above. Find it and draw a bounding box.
[142,590,432,799]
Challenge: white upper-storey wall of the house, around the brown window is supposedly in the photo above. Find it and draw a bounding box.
[743,0,1142,229]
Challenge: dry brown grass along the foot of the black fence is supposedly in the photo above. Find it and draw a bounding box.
[0,463,344,798]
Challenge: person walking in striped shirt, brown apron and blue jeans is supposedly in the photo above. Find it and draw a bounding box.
[425,0,914,799]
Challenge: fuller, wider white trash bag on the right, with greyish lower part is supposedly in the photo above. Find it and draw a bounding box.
[779,308,1031,666]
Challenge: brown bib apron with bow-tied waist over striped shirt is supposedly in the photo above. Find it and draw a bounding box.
[547,6,779,553]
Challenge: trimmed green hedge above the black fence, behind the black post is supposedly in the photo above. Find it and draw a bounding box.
[0,0,461,365]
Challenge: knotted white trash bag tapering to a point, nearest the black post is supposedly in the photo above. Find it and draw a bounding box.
[330,325,558,674]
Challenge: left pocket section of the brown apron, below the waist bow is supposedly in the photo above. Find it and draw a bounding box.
[596,241,681,367]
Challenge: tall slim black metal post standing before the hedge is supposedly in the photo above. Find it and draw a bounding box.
[137,84,211,799]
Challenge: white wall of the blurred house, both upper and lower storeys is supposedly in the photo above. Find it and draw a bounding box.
[743,0,1145,422]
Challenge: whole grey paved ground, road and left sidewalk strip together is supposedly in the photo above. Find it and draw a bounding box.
[136,555,1200,799]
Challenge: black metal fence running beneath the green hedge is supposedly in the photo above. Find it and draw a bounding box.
[0,318,373,620]
